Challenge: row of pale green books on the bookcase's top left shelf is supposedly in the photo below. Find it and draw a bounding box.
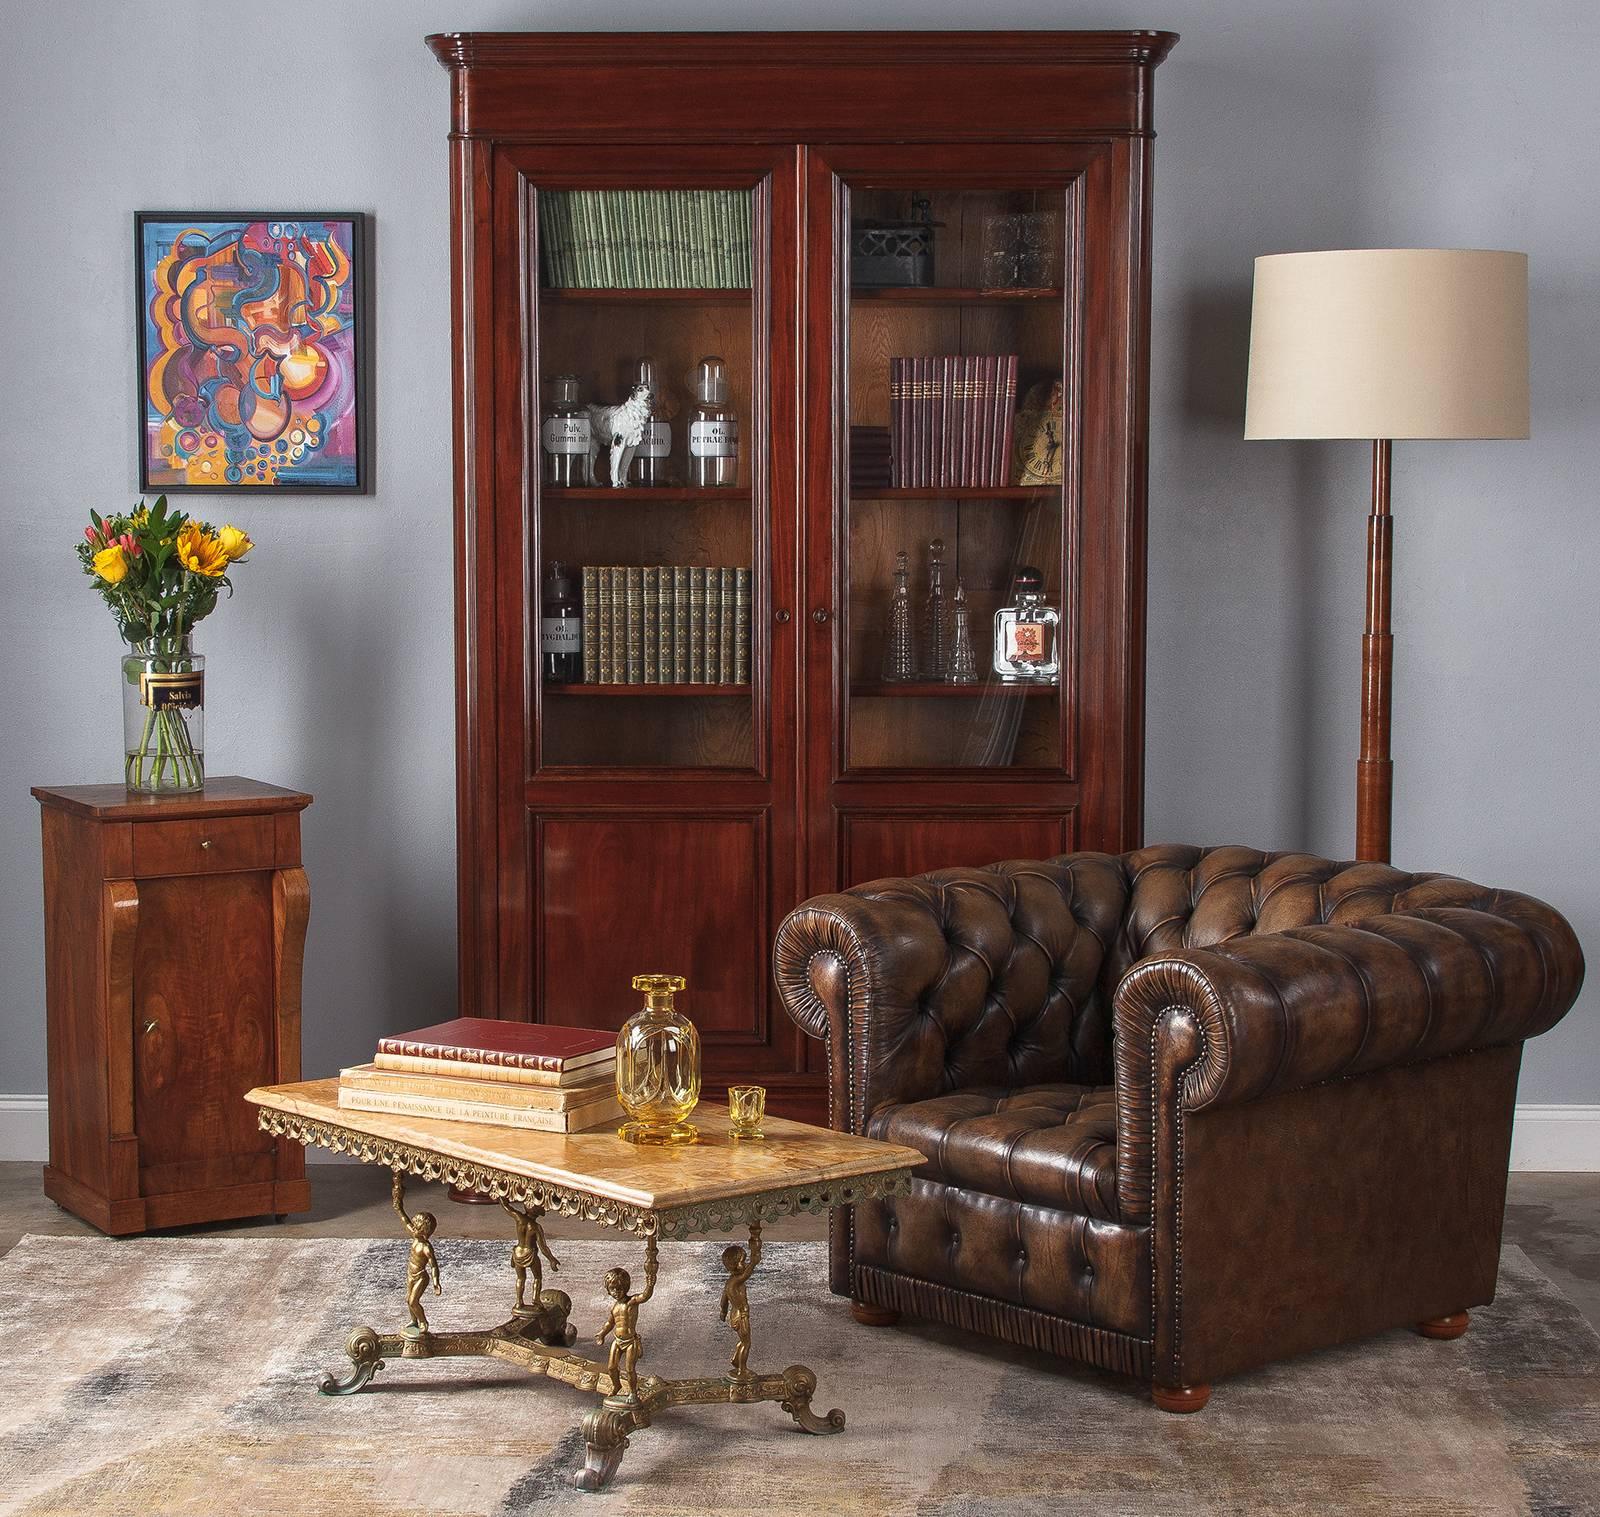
[539,190,750,290]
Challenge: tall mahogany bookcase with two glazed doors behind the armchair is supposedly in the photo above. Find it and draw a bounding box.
[429,32,1176,1119]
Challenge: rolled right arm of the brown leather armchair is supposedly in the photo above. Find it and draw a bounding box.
[1114,879,1584,1216]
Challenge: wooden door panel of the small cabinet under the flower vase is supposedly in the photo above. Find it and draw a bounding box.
[133,872,275,1195]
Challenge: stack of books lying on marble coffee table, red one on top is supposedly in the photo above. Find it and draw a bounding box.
[339,1016,622,1133]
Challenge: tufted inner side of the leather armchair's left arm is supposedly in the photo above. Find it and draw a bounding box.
[850,853,1128,1095]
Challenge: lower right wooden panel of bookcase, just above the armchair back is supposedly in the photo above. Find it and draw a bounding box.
[840,811,1072,885]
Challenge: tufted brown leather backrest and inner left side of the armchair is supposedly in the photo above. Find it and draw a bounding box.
[848,845,1493,1098]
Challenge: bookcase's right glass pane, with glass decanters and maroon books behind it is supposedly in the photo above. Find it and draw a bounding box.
[835,170,1077,773]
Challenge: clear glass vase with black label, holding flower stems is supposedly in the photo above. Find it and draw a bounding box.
[122,632,205,795]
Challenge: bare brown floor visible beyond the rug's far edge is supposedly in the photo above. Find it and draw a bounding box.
[0,1163,1600,1331]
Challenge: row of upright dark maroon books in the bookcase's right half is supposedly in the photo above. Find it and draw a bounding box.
[890,354,1016,490]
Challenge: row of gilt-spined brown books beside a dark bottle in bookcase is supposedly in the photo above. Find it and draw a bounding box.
[582,563,750,685]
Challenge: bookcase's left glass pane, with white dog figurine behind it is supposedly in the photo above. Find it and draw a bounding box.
[528,181,770,770]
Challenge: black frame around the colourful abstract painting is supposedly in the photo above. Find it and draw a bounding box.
[133,211,373,499]
